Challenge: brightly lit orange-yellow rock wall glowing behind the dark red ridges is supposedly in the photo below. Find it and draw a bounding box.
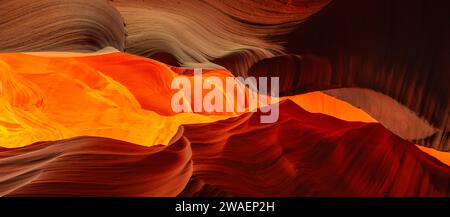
[0,52,448,164]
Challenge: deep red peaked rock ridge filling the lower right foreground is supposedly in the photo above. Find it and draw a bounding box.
[182,101,450,196]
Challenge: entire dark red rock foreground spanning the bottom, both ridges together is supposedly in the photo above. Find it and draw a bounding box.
[0,101,450,196]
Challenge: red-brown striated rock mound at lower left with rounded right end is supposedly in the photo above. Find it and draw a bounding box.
[0,128,193,196]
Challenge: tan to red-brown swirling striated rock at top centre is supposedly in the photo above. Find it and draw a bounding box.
[113,0,330,74]
